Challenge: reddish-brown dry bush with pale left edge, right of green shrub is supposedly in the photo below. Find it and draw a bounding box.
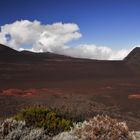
[53,115,134,140]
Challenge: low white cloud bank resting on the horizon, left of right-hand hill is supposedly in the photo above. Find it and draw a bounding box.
[48,44,132,60]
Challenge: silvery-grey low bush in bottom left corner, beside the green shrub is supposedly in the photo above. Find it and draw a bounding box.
[0,118,52,140]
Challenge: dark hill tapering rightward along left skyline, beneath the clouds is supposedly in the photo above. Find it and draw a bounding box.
[0,44,74,63]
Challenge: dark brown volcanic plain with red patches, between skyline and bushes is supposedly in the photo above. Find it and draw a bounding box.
[0,44,140,130]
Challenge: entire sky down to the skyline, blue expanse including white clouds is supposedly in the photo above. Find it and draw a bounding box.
[0,0,140,60]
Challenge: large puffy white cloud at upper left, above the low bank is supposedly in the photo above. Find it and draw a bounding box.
[0,20,81,51]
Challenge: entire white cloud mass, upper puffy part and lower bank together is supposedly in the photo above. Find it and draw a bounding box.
[0,20,131,60]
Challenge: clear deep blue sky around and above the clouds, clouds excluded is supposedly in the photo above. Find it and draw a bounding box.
[0,0,140,59]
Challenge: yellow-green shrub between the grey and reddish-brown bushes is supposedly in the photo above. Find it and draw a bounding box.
[14,107,73,134]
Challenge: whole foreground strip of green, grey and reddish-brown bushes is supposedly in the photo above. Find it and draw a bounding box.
[0,106,139,140]
